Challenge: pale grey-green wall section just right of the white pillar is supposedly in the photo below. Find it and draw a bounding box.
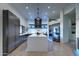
[63,15,71,43]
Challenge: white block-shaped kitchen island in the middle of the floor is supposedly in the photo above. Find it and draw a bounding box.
[27,34,48,52]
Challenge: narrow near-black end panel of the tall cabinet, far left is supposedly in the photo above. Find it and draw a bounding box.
[3,10,8,56]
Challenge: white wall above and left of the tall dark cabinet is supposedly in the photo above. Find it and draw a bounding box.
[0,4,28,55]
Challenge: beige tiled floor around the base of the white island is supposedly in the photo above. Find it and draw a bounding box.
[8,42,73,56]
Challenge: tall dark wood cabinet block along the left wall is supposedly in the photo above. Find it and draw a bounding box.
[3,10,20,56]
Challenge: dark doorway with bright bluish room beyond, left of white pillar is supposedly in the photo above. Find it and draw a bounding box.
[49,23,60,42]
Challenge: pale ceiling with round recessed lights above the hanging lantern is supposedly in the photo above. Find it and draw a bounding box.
[10,3,69,19]
